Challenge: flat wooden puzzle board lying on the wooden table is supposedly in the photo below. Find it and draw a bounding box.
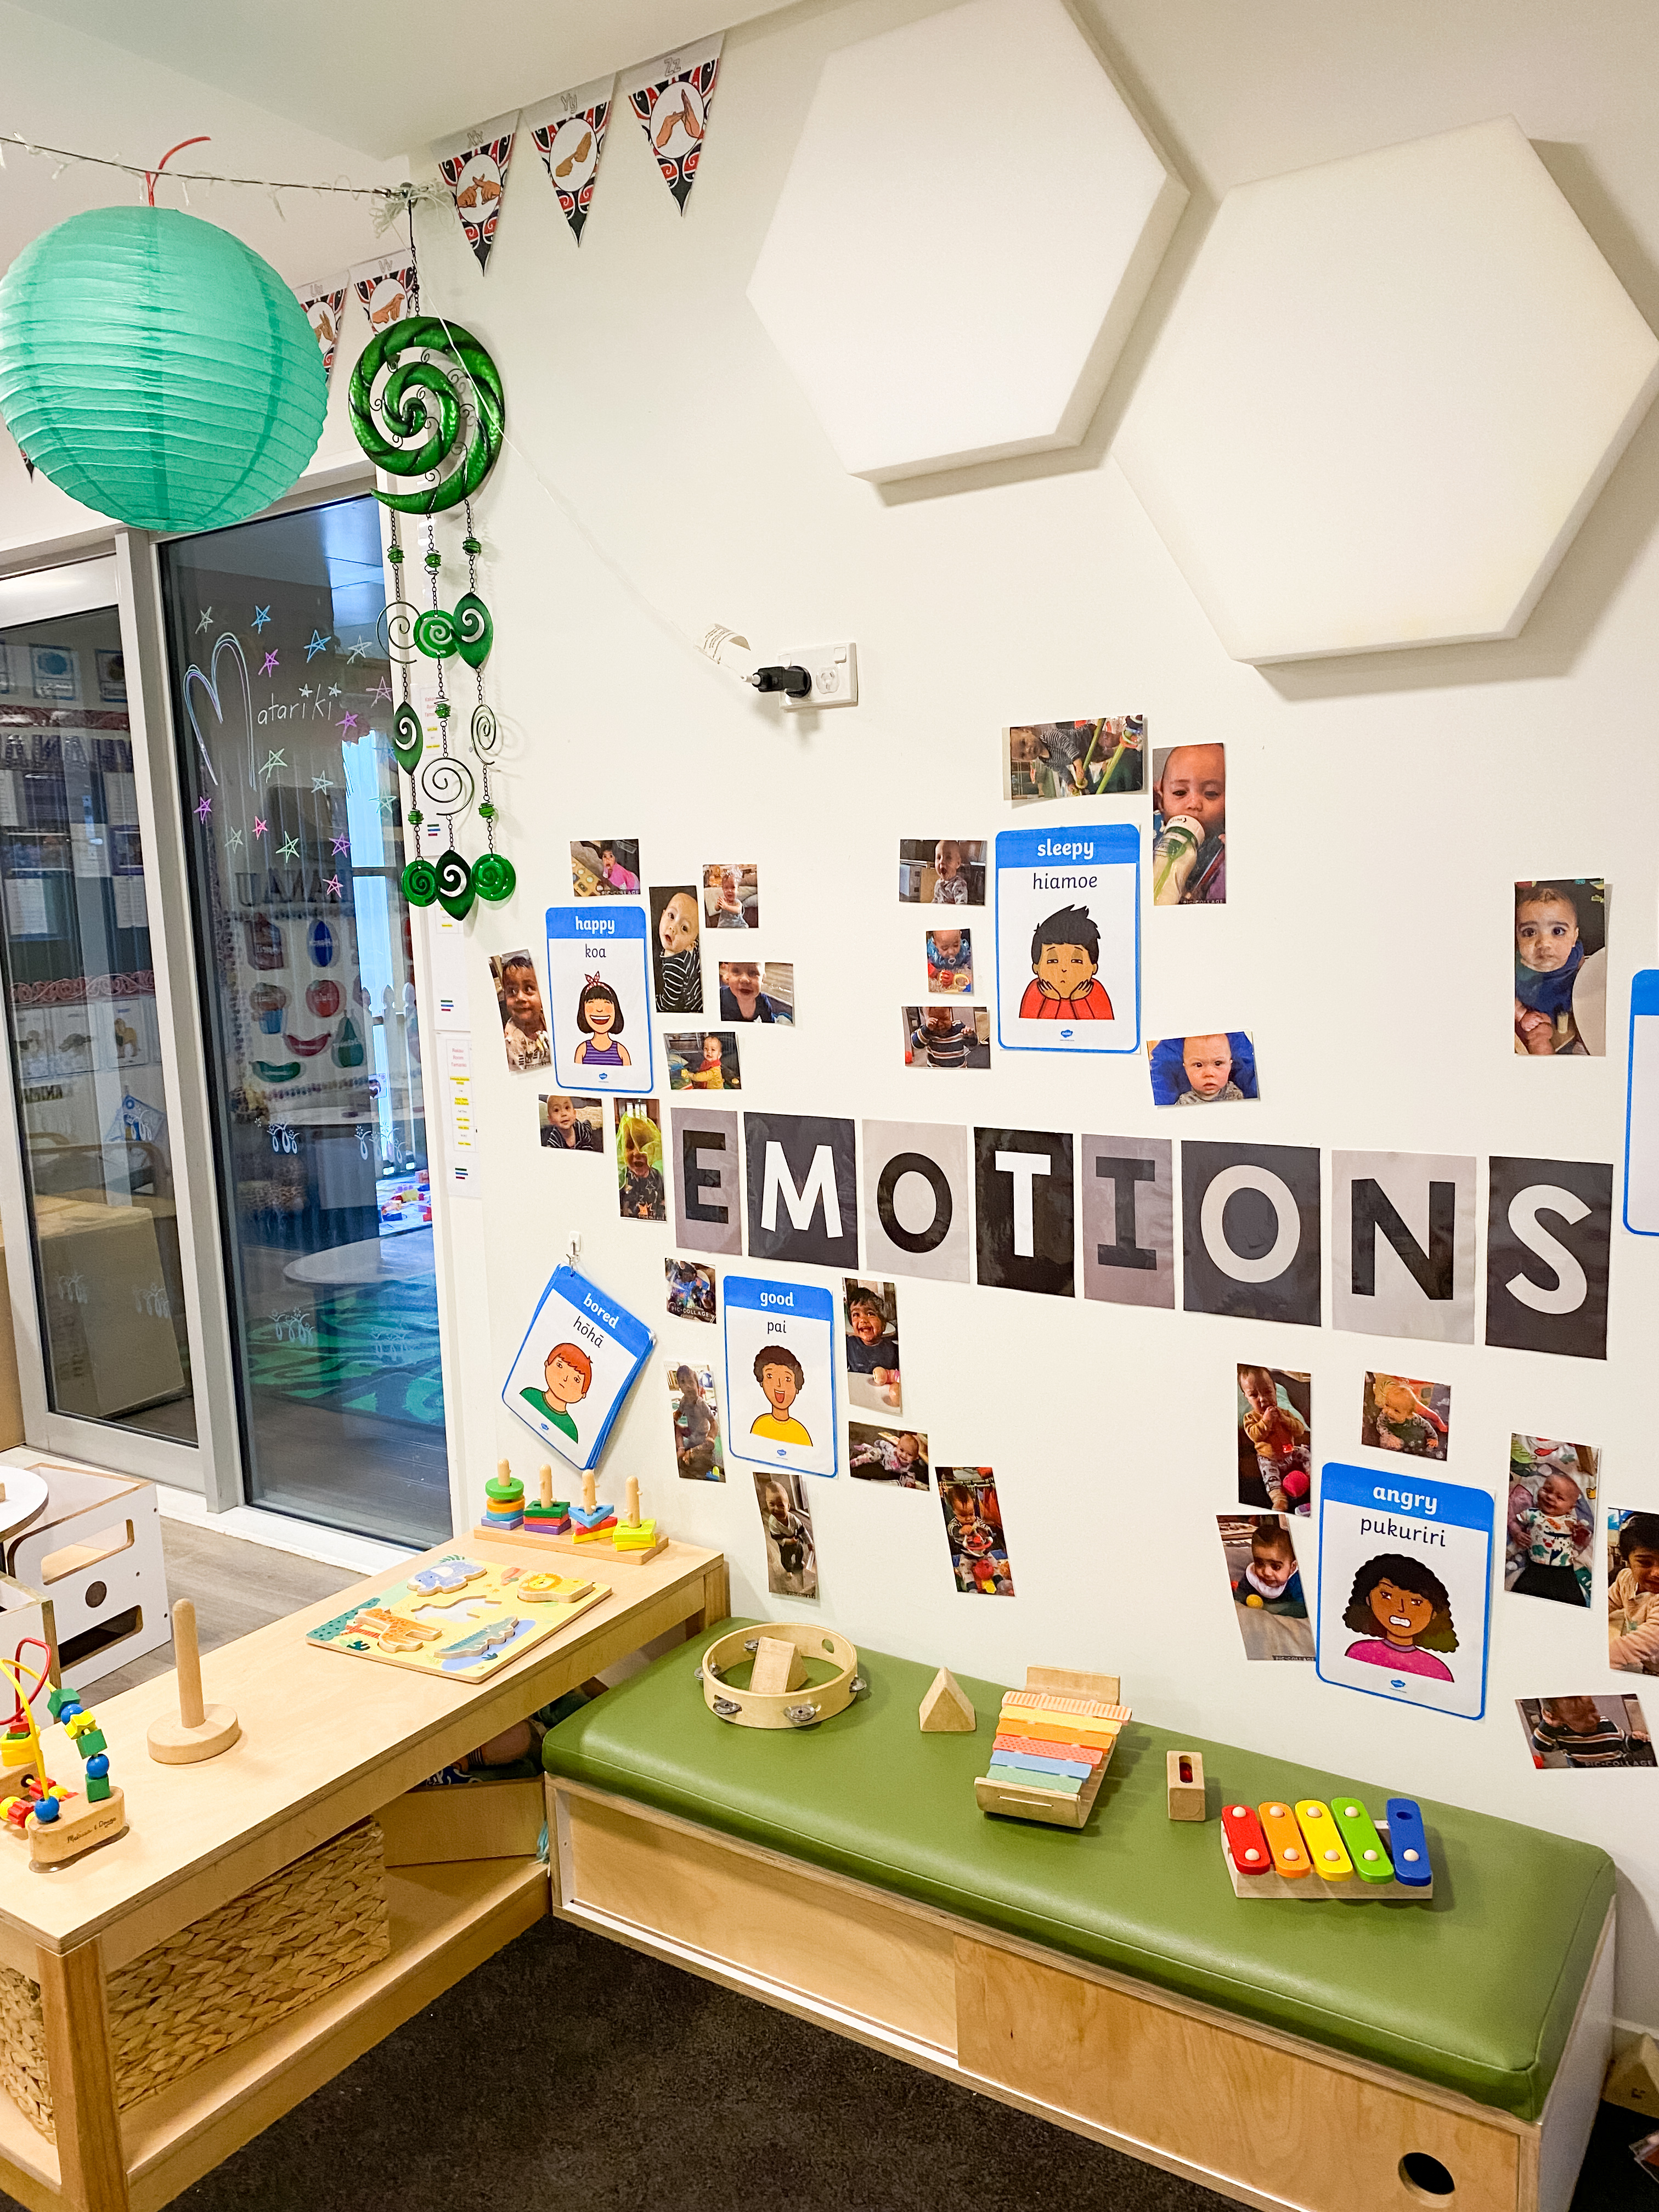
[305,1553,611,1681]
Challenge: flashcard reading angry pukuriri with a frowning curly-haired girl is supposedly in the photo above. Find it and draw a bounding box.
[1316,1460,1493,1721]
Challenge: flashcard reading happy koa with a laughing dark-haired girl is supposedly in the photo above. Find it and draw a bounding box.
[546,900,652,1097]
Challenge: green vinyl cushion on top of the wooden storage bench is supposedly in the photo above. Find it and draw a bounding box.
[553,1621,1612,2119]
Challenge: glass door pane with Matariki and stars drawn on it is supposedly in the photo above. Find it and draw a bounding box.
[161,498,449,1544]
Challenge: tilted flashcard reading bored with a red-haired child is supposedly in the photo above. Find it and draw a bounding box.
[502,1267,657,1471]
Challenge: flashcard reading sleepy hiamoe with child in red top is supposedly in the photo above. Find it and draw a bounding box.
[995,823,1142,1053]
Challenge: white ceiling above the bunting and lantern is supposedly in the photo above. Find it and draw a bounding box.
[7,0,776,159]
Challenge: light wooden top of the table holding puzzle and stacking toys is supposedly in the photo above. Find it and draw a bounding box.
[0,1537,721,1973]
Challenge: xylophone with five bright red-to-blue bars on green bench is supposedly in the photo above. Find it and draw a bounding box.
[1221,1796,1434,1905]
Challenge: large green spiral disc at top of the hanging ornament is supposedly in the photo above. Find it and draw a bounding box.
[352,314,506,515]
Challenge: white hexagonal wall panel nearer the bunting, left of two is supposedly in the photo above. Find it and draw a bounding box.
[750,0,1188,482]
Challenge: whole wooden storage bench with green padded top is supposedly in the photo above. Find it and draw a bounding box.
[544,1623,1612,2212]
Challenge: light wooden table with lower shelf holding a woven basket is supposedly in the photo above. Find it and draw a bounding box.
[0,1537,728,2212]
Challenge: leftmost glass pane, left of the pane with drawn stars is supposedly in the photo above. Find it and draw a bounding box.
[0,606,197,1444]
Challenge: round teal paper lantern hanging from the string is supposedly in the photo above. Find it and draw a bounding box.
[0,208,328,531]
